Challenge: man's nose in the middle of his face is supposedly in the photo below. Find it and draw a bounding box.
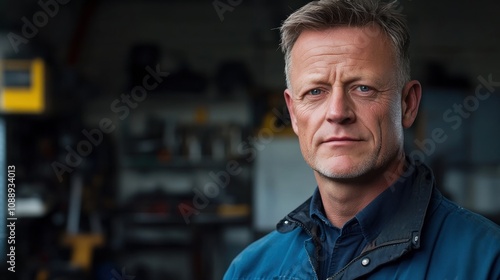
[326,87,356,124]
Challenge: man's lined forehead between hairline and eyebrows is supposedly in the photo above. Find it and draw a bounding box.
[290,27,397,88]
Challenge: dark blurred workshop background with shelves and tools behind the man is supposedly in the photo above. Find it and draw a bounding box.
[0,0,500,280]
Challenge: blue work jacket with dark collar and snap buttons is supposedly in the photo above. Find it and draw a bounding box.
[224,163,500,280]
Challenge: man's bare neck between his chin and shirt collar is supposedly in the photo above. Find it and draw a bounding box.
[315,155,405,228]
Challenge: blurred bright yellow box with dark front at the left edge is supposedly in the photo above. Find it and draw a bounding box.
[0,58,45,114]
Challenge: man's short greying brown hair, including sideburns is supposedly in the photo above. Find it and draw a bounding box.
[280,0,410,88]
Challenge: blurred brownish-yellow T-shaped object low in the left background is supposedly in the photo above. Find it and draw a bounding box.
[63,234,104,270]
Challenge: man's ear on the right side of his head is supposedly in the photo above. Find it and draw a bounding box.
[401,80,422,128]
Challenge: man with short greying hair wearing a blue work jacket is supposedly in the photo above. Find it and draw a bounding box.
[224,0,500,279]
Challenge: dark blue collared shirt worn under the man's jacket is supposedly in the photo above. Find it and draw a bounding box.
[310,174,413,279]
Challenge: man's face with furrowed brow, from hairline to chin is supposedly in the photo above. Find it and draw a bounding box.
[285,27,414,180]
